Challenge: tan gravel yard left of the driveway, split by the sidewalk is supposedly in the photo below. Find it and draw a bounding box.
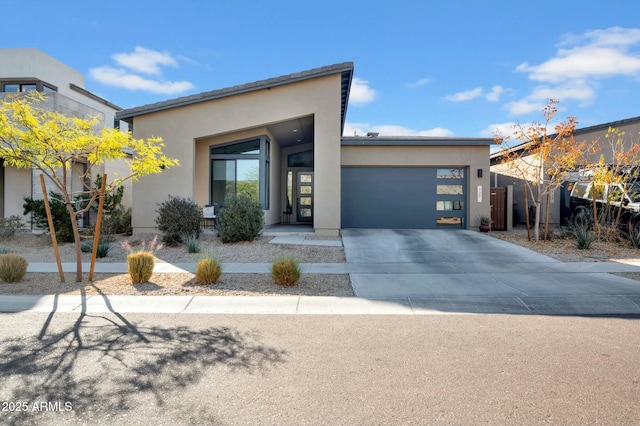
[0,234,353,296]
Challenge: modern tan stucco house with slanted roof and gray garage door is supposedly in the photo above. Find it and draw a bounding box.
[116,62,493,235]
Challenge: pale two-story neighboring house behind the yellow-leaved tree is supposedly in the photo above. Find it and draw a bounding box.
[0,49,131,228]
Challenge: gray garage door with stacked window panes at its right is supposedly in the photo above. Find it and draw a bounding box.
[341,167,467,229]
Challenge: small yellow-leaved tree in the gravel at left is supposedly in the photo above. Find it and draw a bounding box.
[0,91,178,282]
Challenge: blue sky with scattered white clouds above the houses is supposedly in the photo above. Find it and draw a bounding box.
[1,0,640,137]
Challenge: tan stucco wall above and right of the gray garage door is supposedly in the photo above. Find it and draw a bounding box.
[342,145,491,227]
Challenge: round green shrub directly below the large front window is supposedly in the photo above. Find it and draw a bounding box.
[216,194,264,243]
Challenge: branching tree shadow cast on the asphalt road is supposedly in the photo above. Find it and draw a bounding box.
[0,300,287,424]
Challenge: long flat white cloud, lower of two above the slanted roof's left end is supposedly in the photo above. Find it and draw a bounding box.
[89,66,194,95]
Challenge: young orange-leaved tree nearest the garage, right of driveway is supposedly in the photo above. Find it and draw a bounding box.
[494,99,588,242]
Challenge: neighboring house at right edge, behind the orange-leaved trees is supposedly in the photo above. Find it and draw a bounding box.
[491,117,640,224]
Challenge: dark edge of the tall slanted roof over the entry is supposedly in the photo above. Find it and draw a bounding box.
[116,62,353,125]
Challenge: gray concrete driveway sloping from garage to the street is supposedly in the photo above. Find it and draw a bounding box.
[342,229,640,315]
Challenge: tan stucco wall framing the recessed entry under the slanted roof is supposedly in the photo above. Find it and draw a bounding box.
[133,74,341,234]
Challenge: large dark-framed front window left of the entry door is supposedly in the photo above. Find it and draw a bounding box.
[210,136,270,210]
